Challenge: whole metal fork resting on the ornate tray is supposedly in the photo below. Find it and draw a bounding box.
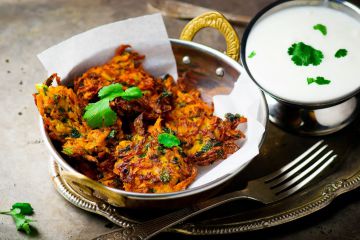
[94,140,337,240]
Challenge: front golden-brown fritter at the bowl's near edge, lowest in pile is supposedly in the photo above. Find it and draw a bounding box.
[114,118,197,193]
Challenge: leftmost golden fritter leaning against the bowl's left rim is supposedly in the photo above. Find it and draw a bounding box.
[34,75,122,162]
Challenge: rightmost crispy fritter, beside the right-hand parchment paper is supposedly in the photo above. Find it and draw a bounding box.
[166,76,246,165]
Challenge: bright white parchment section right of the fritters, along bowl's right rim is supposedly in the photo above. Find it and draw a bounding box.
[190,70,265,188]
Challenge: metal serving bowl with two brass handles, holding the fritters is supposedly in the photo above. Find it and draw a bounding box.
[40,12,268,208]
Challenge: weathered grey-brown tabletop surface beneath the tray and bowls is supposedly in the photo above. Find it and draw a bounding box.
[0,0,360,240]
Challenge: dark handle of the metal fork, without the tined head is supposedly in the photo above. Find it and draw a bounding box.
[94,189,257,240]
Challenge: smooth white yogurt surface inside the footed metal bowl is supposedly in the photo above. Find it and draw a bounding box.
[245,6,360,104]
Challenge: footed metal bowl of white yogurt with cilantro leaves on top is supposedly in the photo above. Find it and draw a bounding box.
[240,0,360,135]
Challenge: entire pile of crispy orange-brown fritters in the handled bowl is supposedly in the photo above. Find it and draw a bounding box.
[34,45,246,193]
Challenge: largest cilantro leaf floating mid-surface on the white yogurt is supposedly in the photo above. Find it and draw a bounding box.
[288,42,324,66]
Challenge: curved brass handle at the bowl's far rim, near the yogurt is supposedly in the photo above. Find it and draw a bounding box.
[180,11,240,61]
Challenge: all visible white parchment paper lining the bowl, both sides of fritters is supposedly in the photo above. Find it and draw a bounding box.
[38,14,264,188]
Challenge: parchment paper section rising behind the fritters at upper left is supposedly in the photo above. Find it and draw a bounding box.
[38,14,177,79]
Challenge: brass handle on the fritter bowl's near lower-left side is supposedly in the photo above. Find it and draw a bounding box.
[61,171,126,207]
